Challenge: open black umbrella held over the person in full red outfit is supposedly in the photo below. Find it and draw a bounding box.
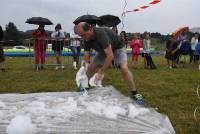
[26,17,53,25]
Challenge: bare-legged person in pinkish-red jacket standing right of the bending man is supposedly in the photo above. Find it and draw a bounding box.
[130,34,142,67]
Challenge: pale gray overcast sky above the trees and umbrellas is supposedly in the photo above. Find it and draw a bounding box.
[0,0,200,34]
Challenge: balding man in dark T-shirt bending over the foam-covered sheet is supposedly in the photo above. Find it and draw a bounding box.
[75,22,144,104]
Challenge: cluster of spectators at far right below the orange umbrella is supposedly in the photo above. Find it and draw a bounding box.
[165,32,200,70]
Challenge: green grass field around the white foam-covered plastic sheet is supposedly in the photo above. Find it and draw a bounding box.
[0,56,200,134]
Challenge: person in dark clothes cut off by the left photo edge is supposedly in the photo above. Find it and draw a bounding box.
[0,26,6,72]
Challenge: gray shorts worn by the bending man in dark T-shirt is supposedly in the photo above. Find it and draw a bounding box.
[93,47,127,66]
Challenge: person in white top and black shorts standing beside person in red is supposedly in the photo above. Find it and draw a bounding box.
[51,24,65,70]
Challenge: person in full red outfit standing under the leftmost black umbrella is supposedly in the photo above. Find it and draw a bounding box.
[32,25,48,71]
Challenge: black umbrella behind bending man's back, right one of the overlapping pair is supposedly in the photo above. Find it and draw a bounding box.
[99,14,121,27]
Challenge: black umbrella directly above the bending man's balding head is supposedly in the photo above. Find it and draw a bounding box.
[73,14,101,25]
